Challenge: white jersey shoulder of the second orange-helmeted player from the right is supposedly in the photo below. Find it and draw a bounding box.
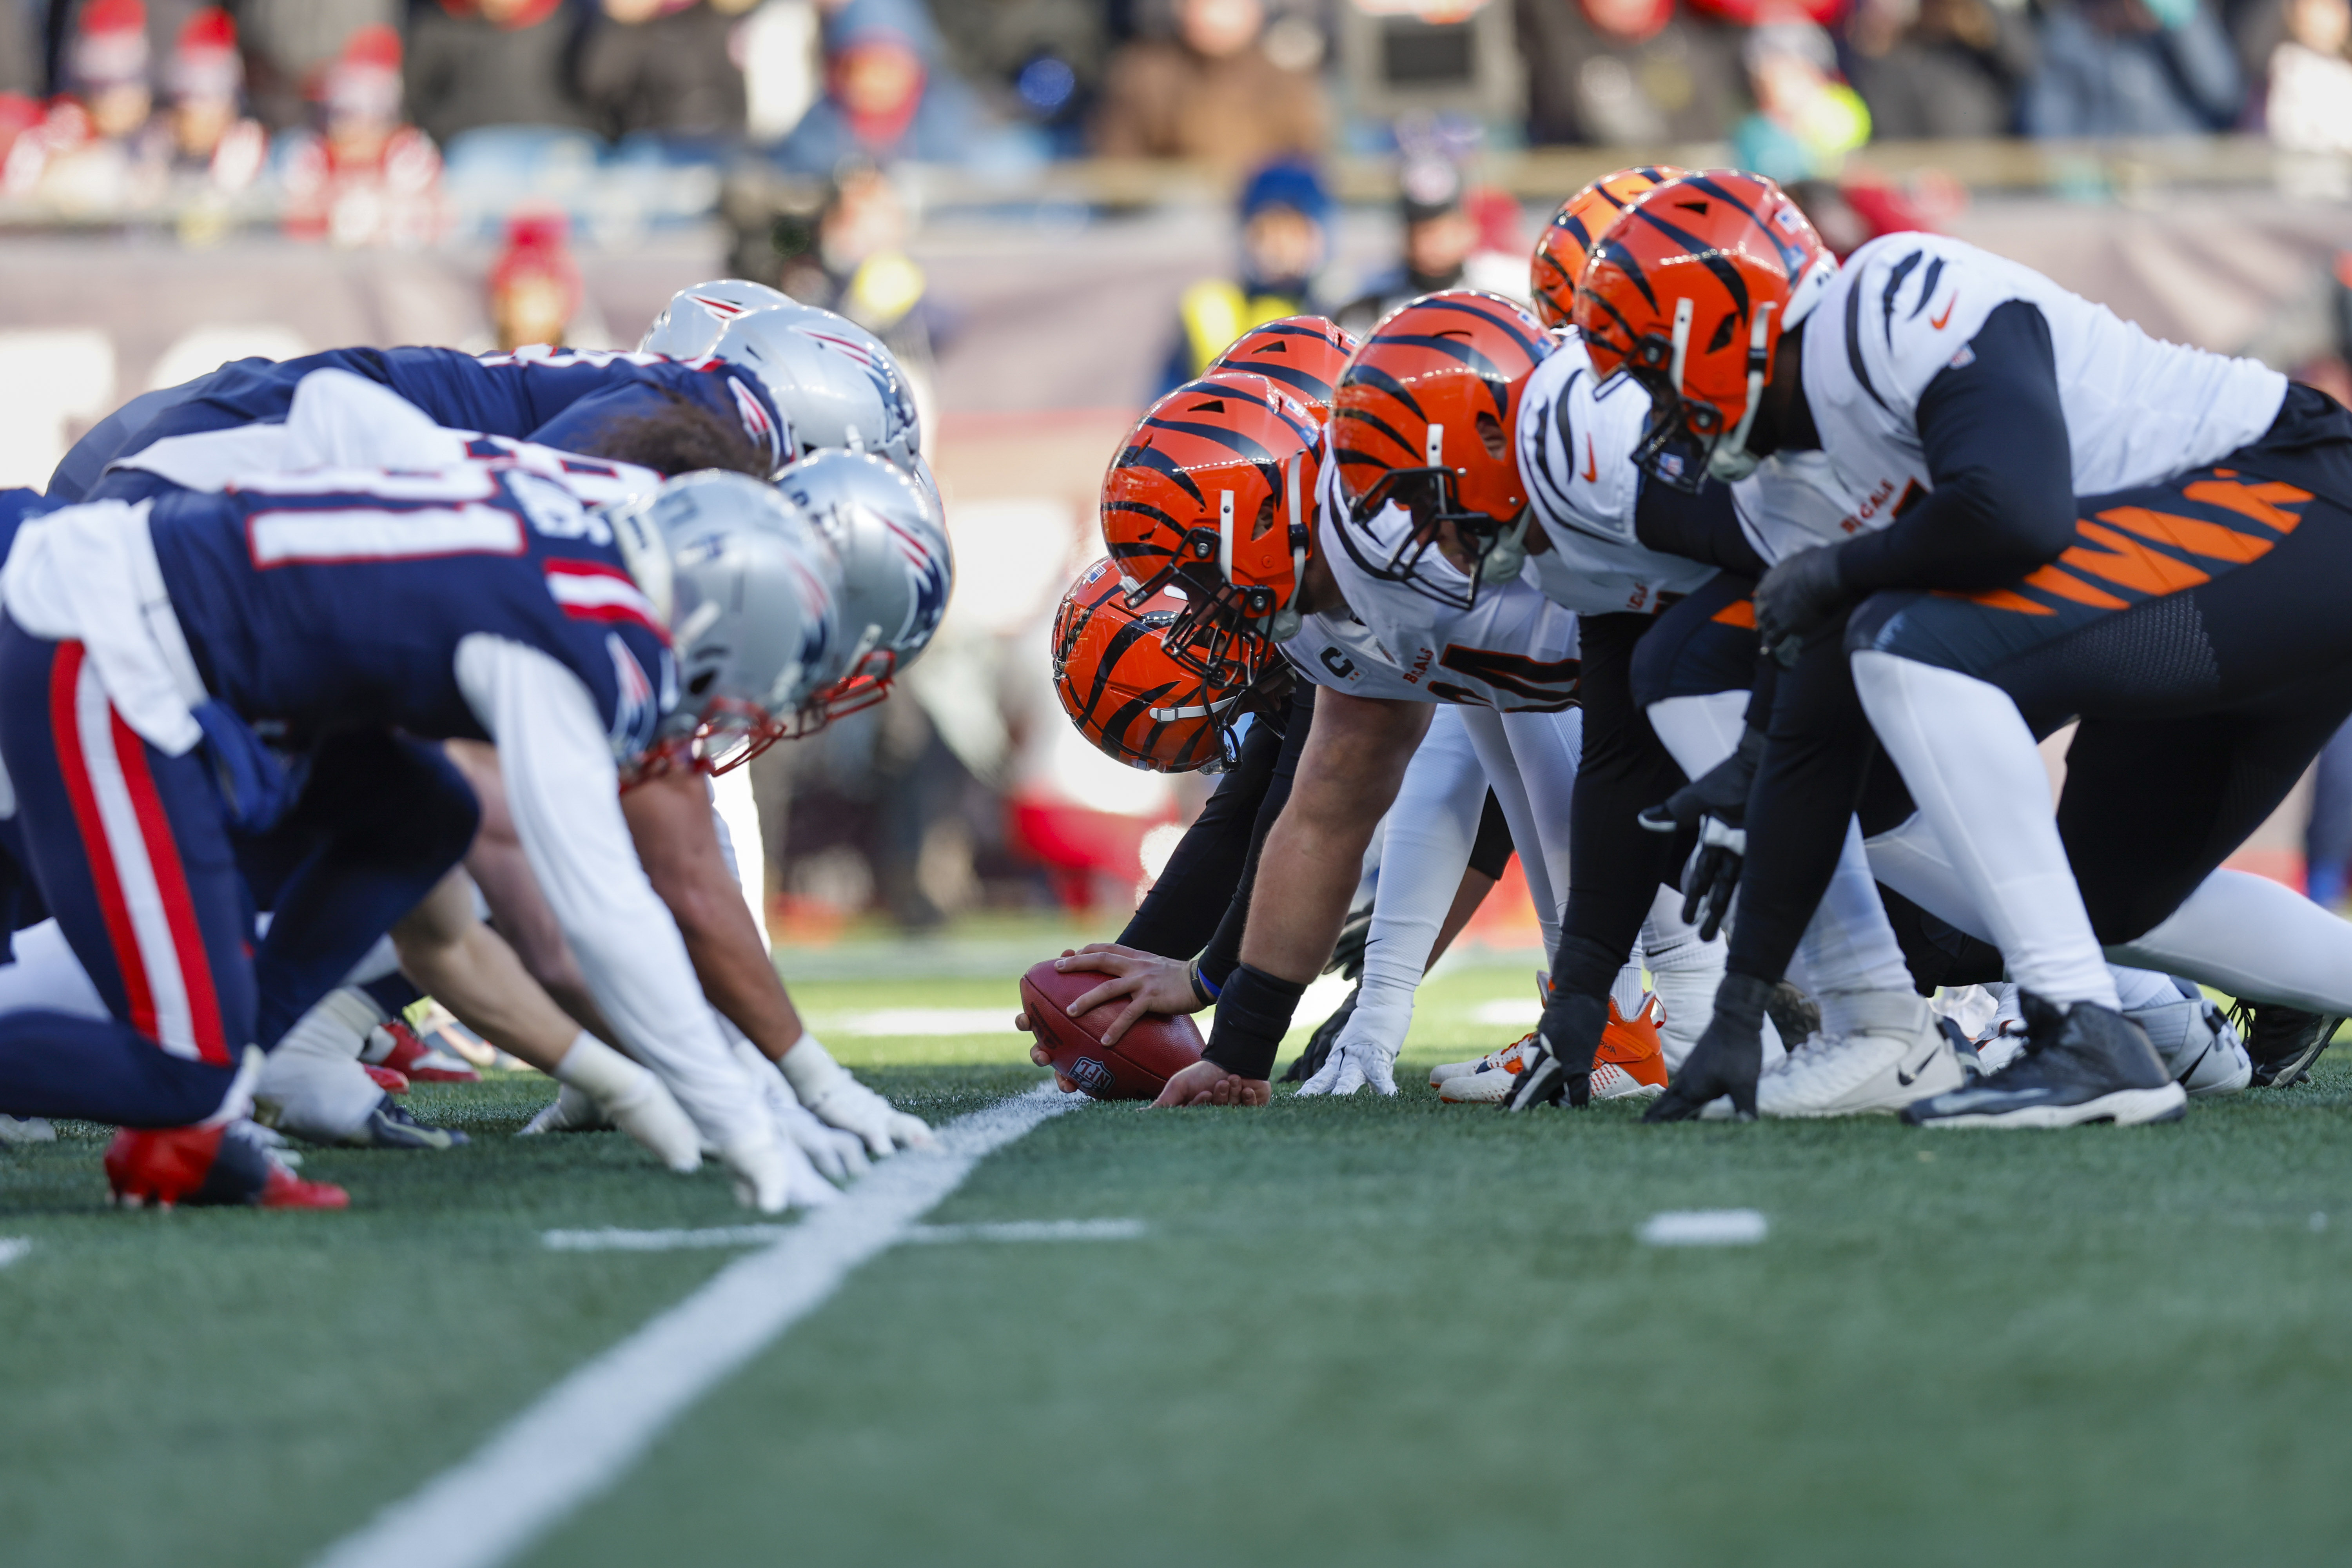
[1517,327,1715,616]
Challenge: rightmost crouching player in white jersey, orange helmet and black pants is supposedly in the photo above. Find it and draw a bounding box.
[1576,174,2352,1126]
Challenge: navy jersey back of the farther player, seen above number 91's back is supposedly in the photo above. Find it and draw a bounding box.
[89,348,786,484]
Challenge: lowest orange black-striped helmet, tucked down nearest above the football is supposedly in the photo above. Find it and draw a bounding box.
[1054,559,1249,773]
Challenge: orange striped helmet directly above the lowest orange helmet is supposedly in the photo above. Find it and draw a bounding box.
[1103,372,1322,684]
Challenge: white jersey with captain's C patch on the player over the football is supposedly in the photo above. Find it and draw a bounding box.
[1282,463,1578,712]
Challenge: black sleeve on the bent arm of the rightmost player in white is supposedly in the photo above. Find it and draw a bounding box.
[1837,299,2074,595]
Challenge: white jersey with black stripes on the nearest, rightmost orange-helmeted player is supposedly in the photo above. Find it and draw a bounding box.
[1804,233,2286,545]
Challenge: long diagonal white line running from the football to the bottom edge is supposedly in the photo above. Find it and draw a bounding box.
[315,1084,1082,1568]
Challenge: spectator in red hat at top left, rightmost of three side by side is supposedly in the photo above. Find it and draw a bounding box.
[282,26,442,245]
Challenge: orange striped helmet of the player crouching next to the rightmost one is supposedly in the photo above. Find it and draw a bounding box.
[1331,289,1552,609]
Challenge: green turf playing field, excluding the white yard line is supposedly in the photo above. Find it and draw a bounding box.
[0,969,2352,1568]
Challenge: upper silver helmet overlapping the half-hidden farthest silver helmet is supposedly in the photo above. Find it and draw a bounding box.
[710,306,922,468]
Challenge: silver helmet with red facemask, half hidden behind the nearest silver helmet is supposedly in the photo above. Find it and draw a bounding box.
[776,451,955,717]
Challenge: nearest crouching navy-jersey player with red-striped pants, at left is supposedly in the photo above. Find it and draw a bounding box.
[0,402,840,1208]
